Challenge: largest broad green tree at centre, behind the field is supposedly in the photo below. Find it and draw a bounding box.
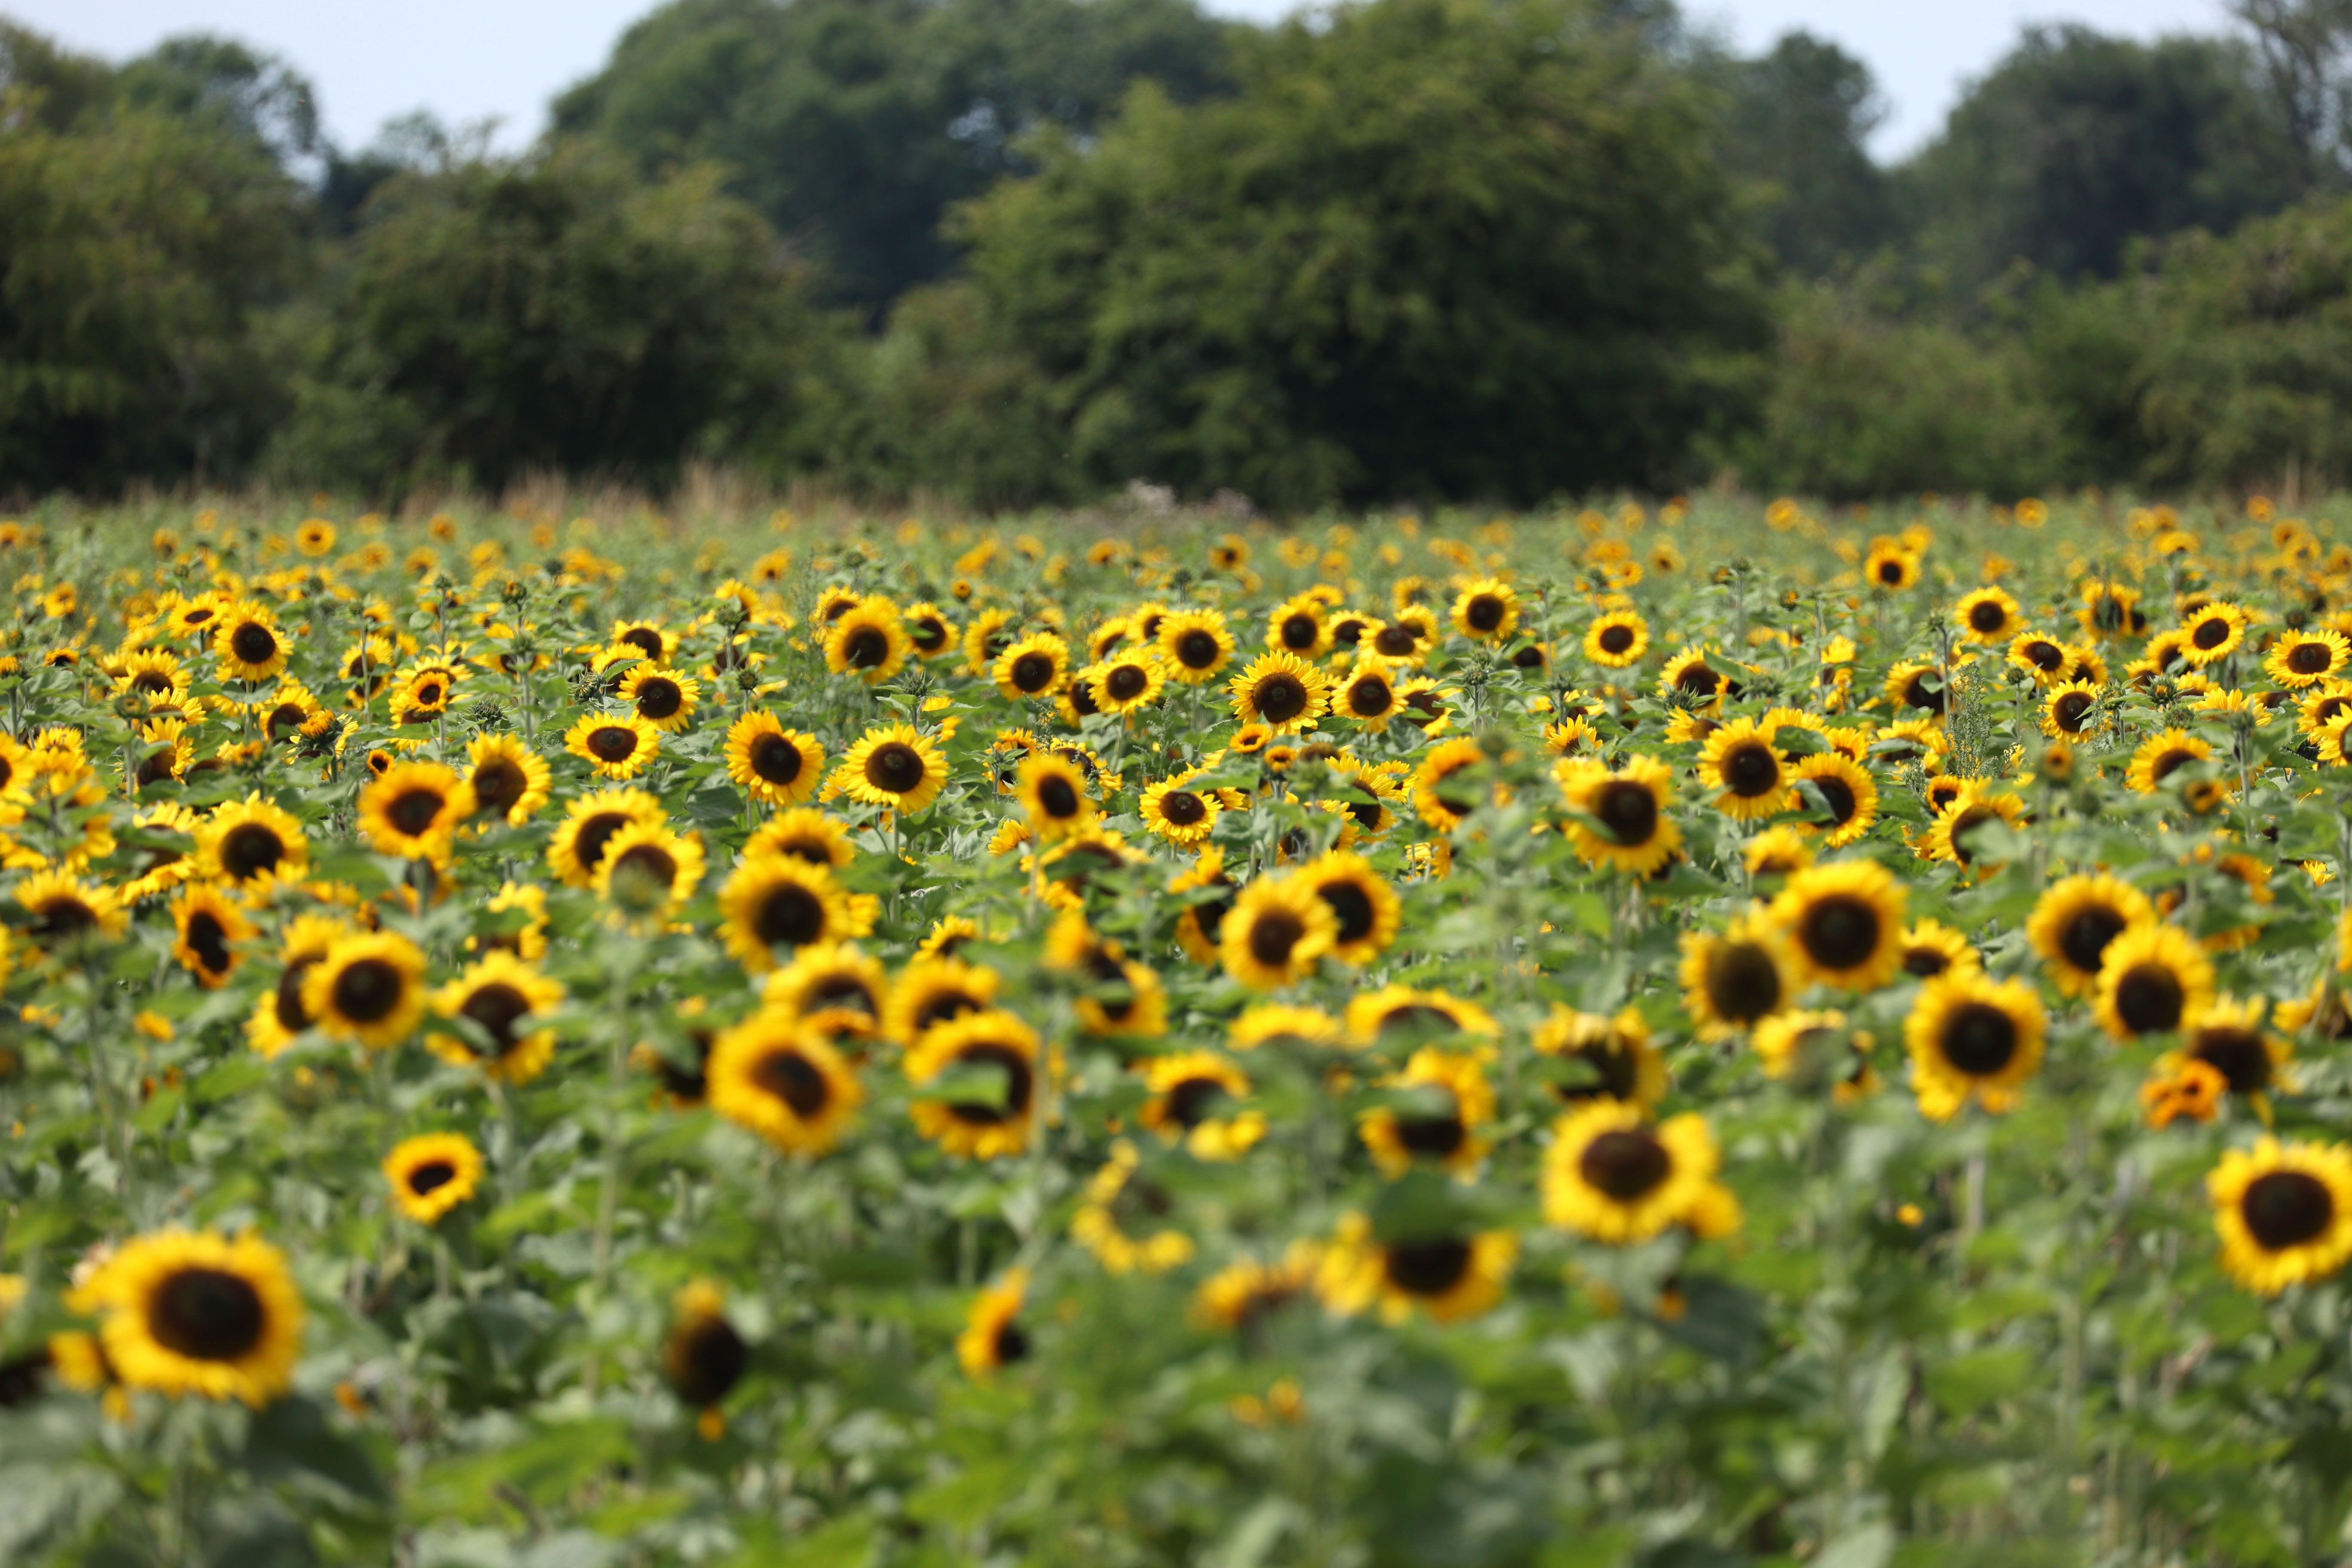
[957,0,1764,505]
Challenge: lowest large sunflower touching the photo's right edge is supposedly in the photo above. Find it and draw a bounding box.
[2206,1138,2352,1295]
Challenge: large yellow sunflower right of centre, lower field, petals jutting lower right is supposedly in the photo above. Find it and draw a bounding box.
[1543,1100,1740,1246]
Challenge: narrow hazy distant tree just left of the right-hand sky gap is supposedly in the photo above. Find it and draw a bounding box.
[1708,33,1898,277]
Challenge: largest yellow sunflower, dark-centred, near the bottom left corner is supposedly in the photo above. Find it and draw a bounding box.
[85,1229,303,1411]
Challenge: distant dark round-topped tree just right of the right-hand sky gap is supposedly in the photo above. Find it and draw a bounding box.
[1903,26,2305,287]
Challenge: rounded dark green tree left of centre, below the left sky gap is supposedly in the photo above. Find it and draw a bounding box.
[273,141,826,487]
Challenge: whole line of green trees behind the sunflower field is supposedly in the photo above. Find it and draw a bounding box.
[14,0,2352,508]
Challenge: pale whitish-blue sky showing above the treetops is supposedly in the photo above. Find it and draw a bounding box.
[0,0,2223,157]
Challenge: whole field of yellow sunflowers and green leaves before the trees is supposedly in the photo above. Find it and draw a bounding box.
[0,496,2352,1568]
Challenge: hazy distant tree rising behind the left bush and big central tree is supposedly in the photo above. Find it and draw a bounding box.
[555,0,1223,306]
